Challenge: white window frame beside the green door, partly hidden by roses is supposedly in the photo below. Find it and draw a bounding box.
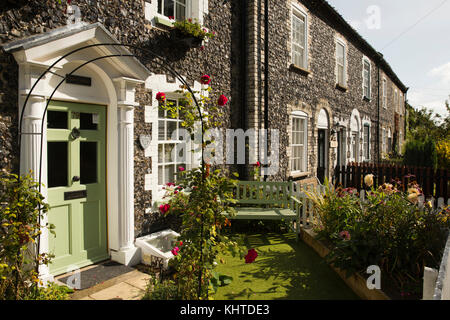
[156,95,189,187]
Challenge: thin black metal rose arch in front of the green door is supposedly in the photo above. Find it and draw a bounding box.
[18,43,205,297]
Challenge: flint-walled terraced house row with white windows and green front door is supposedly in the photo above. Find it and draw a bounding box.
[0,0,407,278]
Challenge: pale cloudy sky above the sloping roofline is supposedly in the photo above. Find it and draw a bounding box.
[328,0,450,117]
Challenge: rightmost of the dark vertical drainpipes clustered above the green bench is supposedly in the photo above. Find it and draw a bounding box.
[264,0,270,181]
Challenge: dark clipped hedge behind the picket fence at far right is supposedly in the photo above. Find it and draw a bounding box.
[403,137,437,169]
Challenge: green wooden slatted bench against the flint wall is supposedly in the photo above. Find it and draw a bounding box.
[223,181,301,236]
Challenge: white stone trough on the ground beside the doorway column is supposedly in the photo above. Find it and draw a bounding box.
[136,229,180,270]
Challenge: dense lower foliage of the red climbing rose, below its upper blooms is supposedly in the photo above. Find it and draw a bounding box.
[163,169,243,300]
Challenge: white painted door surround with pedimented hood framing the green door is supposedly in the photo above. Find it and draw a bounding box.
[8,24,148,279]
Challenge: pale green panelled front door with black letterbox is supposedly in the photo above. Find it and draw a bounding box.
[47,101,108,275]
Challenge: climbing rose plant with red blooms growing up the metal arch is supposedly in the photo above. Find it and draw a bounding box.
[159,75,246,300]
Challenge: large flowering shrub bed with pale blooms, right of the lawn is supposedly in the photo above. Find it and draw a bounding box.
[310,177,450,291]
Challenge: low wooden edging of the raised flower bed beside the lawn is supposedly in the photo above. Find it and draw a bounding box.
[300,229,391,300]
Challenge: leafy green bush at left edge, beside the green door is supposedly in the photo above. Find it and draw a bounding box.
[0,174,57,300]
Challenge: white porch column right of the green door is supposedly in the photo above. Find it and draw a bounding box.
[111,78,141,265]
